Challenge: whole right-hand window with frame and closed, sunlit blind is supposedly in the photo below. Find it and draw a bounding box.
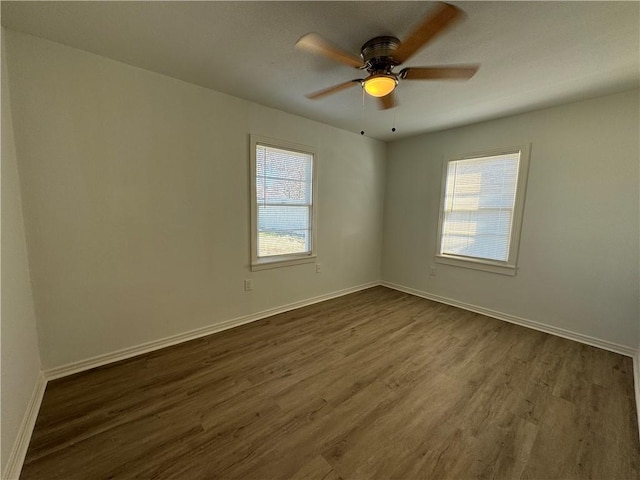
[436,146,529,275]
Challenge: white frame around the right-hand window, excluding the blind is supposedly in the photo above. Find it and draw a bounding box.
[435,144,531,276]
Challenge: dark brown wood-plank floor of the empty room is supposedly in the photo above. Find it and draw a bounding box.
[21,287,640,480]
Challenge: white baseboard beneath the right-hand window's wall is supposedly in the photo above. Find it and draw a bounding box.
[381,281,636,357]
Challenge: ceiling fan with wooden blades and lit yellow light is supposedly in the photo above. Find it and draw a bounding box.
[296,3,480,109]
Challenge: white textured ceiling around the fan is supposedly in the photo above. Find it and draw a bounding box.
[1,1,640,140]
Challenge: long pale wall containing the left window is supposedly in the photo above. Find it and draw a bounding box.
[6,31,386,369]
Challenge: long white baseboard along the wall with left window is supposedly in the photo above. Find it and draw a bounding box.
[44,282,380,380]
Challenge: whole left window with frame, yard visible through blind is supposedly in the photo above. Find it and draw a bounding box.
[251,135,316,270]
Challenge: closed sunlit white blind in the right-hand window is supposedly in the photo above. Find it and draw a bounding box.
[440,151,520,262]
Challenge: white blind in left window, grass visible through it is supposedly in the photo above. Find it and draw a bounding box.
[255,144,314,258]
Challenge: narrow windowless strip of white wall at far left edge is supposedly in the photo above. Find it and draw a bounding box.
[0,32,40,478]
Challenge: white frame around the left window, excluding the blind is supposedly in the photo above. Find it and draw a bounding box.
[250,135,318,271]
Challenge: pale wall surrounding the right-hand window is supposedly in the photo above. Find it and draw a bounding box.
[382,91,640,350]
